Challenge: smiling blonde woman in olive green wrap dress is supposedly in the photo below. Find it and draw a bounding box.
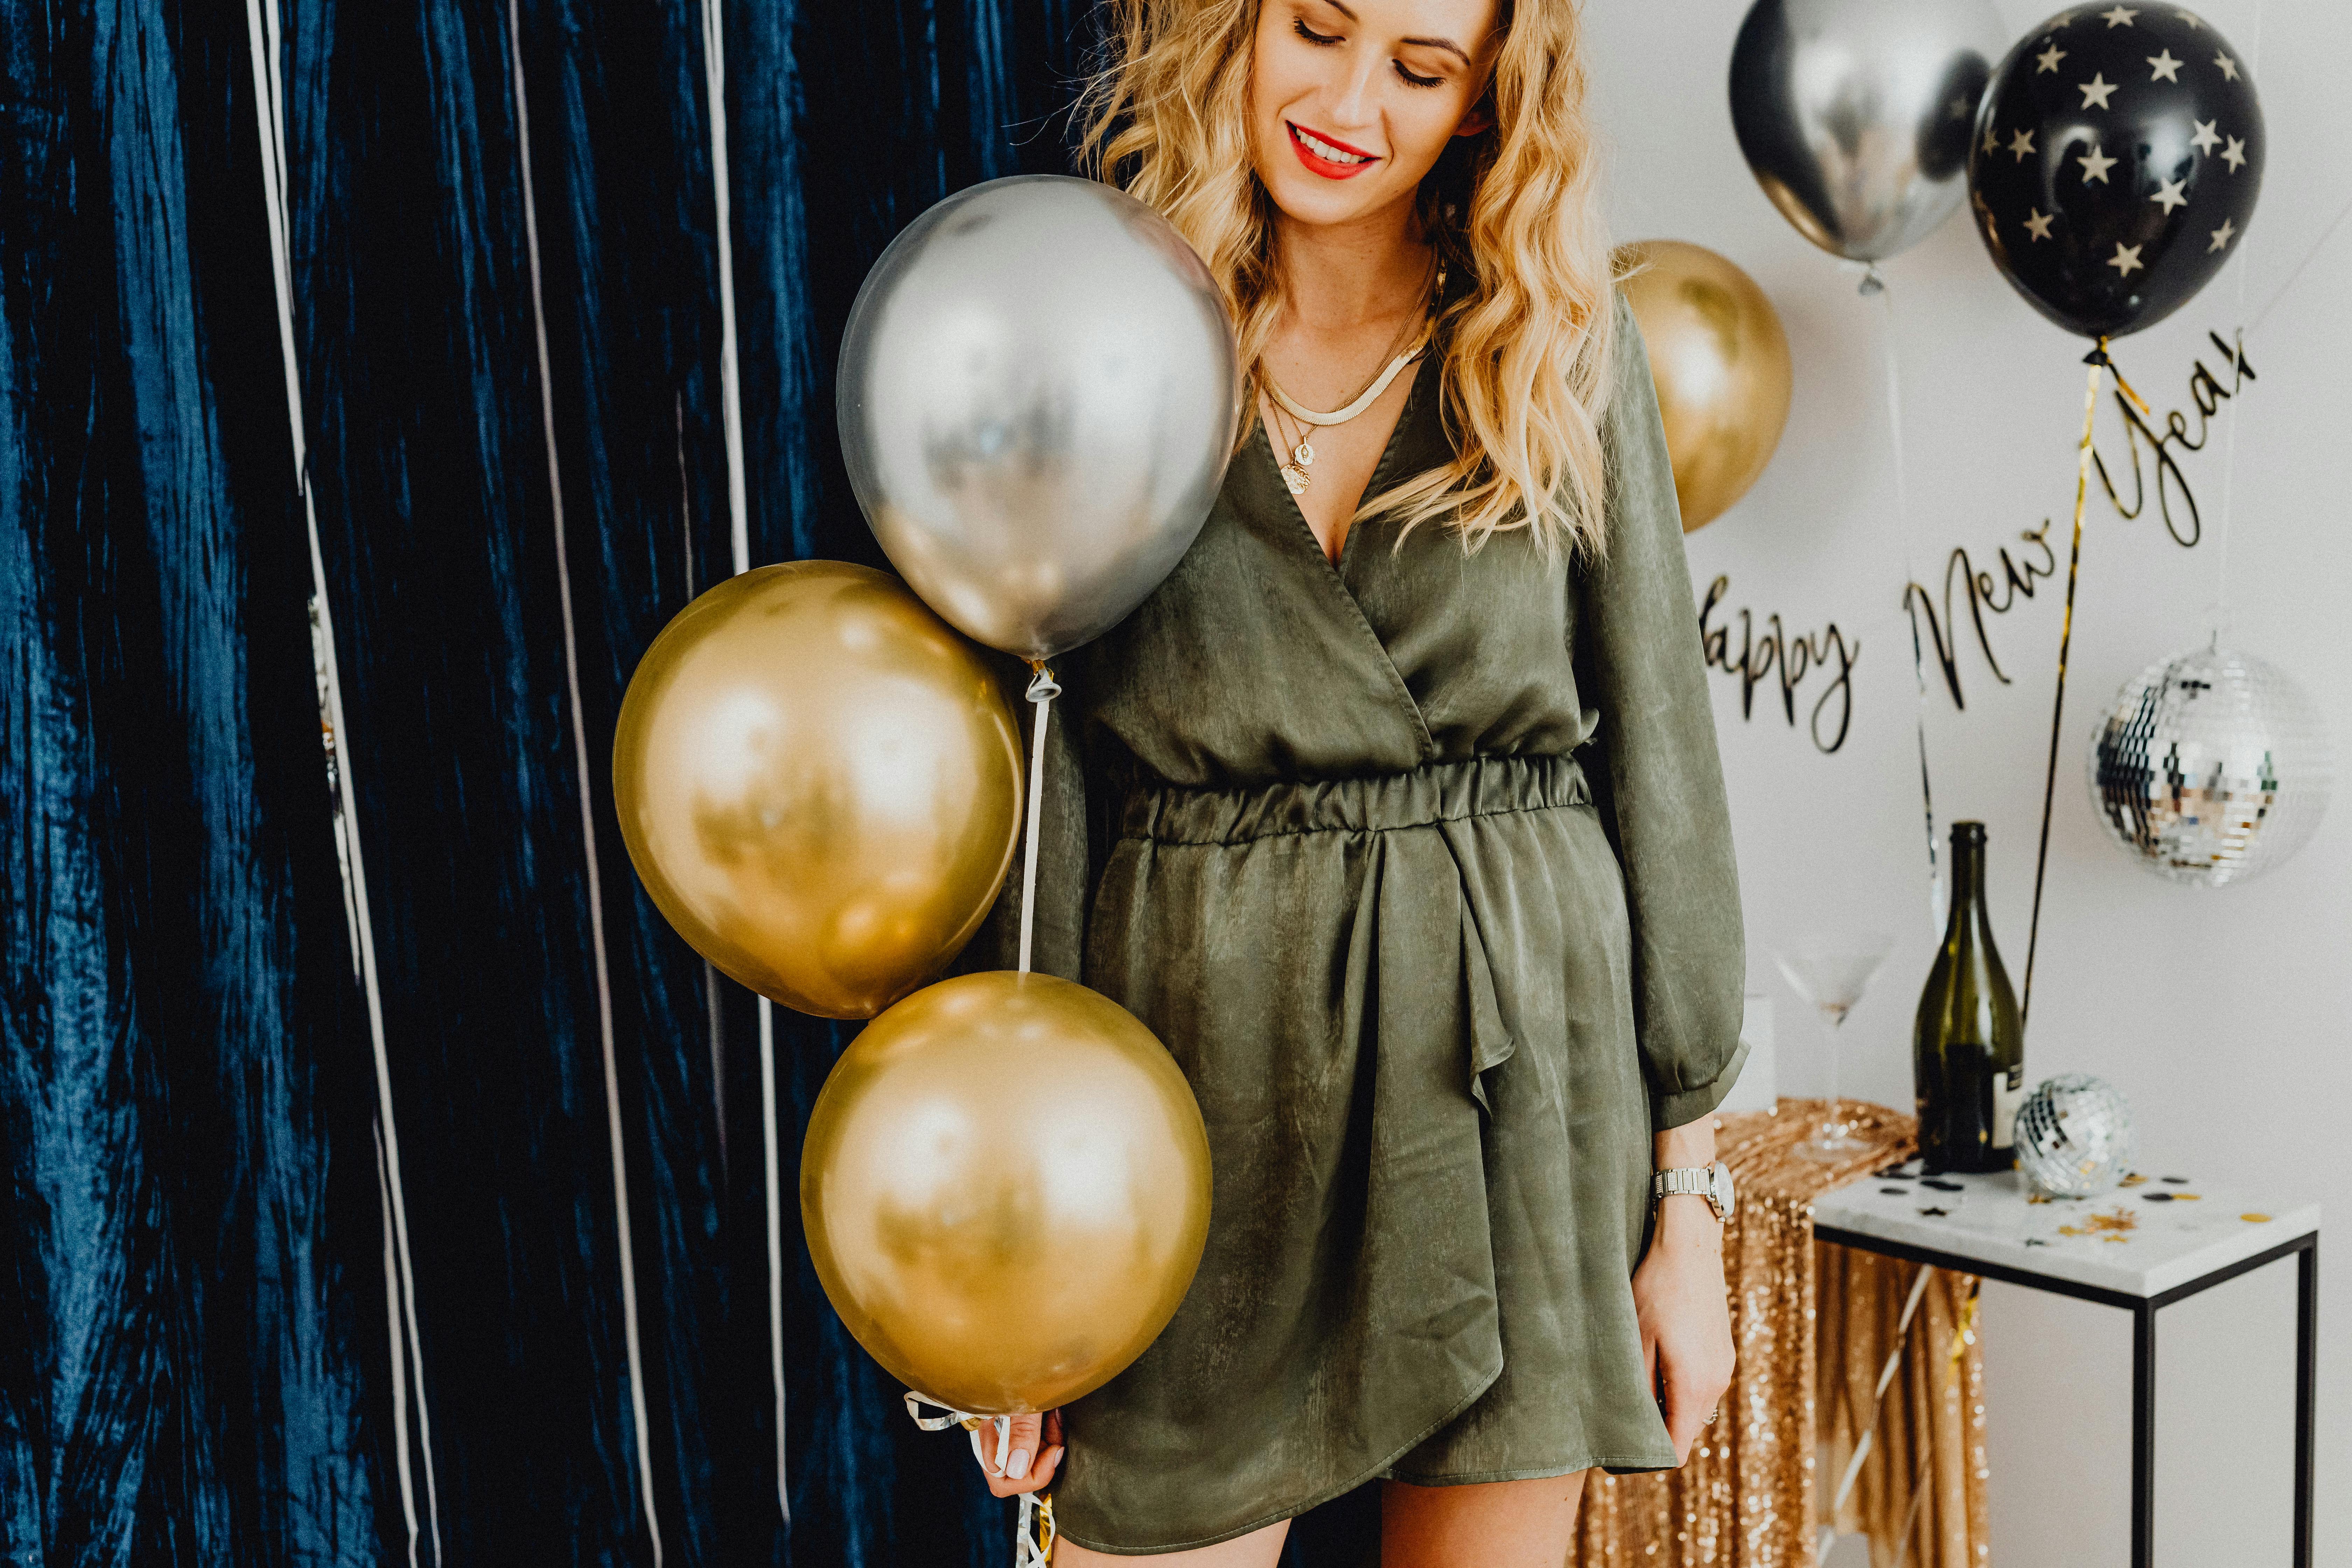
[964,0,1743,1568]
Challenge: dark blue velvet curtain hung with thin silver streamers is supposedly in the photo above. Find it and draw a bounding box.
[0,0,1366,1568]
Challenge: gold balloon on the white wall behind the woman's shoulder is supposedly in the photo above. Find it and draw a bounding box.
[1618,240,1790,534]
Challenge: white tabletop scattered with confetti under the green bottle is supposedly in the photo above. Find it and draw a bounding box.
[1813,1159,2319,1295]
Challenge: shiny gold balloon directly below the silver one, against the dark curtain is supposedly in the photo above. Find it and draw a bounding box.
[611,562,1021,1018]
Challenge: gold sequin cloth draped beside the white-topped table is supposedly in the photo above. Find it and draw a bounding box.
[1571,1100,1987,1568]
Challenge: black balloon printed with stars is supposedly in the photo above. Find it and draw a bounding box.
[1969,5,2263,338]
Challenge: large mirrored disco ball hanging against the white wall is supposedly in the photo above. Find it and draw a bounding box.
[2091,644,2336,886]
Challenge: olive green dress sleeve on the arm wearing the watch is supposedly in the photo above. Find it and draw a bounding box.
[1581,299,1748,1128]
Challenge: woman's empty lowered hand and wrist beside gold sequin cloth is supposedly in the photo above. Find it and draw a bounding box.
[1632,1116,1736,1464]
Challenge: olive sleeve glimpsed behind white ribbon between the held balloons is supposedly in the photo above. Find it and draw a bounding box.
[955,656,1094,980]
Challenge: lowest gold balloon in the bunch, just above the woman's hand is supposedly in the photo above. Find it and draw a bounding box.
[800,971,1209,1415]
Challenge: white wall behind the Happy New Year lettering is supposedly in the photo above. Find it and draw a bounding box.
[1585,0,2352,1568]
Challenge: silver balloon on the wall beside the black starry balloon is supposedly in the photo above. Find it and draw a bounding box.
[1731,0,2009,261]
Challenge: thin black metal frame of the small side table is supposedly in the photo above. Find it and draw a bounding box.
[1813,1225,2319,1568]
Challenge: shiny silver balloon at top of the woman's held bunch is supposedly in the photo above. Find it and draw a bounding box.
[837,174,1239,658]
